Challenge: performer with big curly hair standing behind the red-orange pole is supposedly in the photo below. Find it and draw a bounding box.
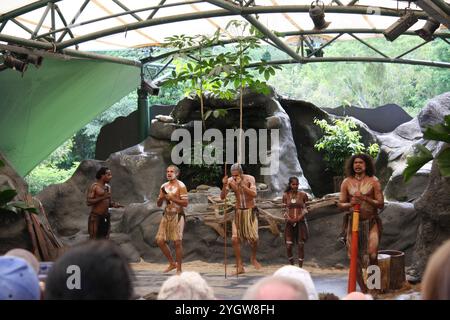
[338,153,384,293]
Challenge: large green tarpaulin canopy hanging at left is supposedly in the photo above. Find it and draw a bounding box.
[0,58,140,176]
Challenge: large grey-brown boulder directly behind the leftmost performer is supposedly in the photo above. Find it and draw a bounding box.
[37,137,170,259]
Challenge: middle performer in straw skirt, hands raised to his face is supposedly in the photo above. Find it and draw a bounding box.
[220,163,261,274]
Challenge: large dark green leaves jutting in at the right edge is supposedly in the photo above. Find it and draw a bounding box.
[403,115,450,182]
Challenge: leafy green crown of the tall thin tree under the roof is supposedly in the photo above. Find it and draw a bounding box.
[164,20,281,105]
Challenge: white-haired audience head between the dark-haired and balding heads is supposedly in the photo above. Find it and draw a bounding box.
[158,271,215,300]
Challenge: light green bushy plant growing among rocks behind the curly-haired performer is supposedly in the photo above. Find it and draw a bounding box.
[314,117,380,175]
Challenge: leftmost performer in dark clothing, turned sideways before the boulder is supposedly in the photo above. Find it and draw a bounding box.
[87,167,123,239]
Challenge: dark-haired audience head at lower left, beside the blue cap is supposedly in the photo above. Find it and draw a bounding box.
[45,240,133,300]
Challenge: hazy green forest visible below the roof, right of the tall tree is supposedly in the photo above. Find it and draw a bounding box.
[268,36,450,116]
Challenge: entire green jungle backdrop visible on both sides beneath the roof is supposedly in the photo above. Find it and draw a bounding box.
[25,36,450,194]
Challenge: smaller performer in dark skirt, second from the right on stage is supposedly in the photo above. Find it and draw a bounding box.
[283,177,308,268]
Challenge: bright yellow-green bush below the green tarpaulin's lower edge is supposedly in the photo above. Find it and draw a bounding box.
[25,162,79,195]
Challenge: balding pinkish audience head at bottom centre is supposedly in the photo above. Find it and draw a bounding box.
[242,276,308,300]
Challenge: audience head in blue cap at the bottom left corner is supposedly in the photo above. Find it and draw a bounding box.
[0,256,41,300]
